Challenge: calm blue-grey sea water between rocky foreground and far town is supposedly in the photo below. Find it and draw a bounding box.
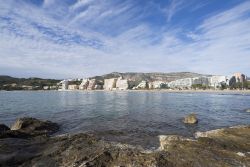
[0,91,250,147]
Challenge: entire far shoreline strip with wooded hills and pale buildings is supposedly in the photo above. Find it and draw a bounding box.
[0,72,250,91]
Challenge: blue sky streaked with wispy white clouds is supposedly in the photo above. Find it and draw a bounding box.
[0,0,250,78]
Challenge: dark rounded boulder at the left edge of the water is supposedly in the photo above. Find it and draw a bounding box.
[11,117,59,135]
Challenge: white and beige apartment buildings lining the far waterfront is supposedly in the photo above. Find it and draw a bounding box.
[58,73,250,91]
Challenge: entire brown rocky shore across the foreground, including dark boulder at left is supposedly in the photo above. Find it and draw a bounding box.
[0,118,250,167]
